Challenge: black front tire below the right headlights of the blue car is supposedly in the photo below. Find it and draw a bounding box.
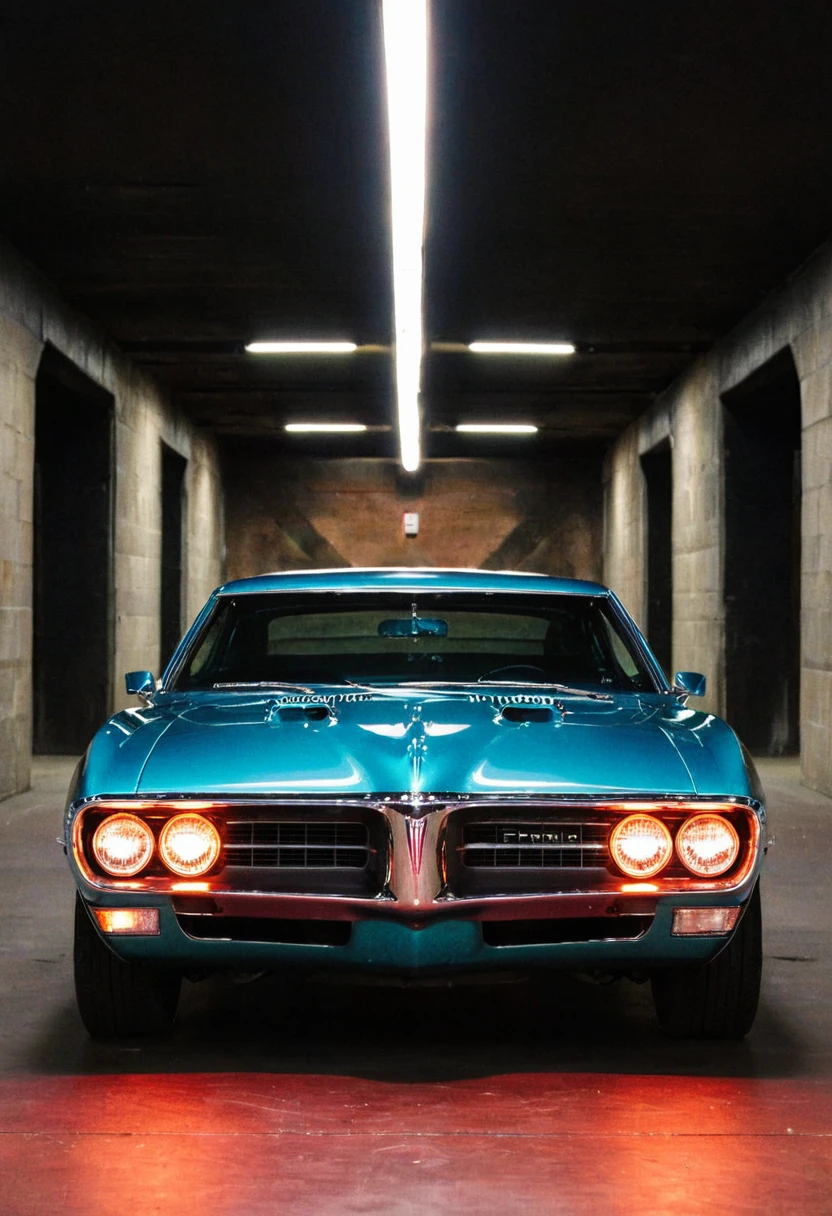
[652,883,763,1038]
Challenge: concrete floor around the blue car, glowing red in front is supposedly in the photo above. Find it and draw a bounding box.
[0,758,832,1216]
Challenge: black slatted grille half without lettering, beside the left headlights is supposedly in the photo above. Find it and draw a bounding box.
[225,820,370,869]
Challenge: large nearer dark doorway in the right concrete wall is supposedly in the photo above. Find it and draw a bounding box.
[723,350,800,755]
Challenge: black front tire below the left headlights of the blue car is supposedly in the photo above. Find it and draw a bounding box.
[75,895,182,1038]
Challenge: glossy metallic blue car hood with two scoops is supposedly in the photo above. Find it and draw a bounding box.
[77,689,747,796]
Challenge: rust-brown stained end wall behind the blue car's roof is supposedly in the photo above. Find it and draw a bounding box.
[224,441,602,579]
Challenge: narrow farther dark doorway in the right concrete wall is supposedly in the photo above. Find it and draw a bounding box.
[641,440,673,676]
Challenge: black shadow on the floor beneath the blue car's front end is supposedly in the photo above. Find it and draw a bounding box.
[27,974,806,1083]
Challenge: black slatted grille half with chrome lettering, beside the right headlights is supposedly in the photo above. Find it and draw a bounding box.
[460,821,609,869]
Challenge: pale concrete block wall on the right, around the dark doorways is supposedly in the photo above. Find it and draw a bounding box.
[605,243,832,794]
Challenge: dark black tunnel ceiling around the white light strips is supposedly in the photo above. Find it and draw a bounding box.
[0,0,832,455]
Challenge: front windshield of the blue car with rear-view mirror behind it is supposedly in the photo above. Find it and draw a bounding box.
[169,592,657,692]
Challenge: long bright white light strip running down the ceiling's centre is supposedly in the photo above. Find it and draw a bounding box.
[383,0,427,473]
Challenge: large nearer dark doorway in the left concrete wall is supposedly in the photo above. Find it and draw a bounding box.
[33,347,113,755]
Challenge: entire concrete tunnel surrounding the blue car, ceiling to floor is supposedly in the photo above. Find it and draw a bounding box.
[0,0,832,1216]
